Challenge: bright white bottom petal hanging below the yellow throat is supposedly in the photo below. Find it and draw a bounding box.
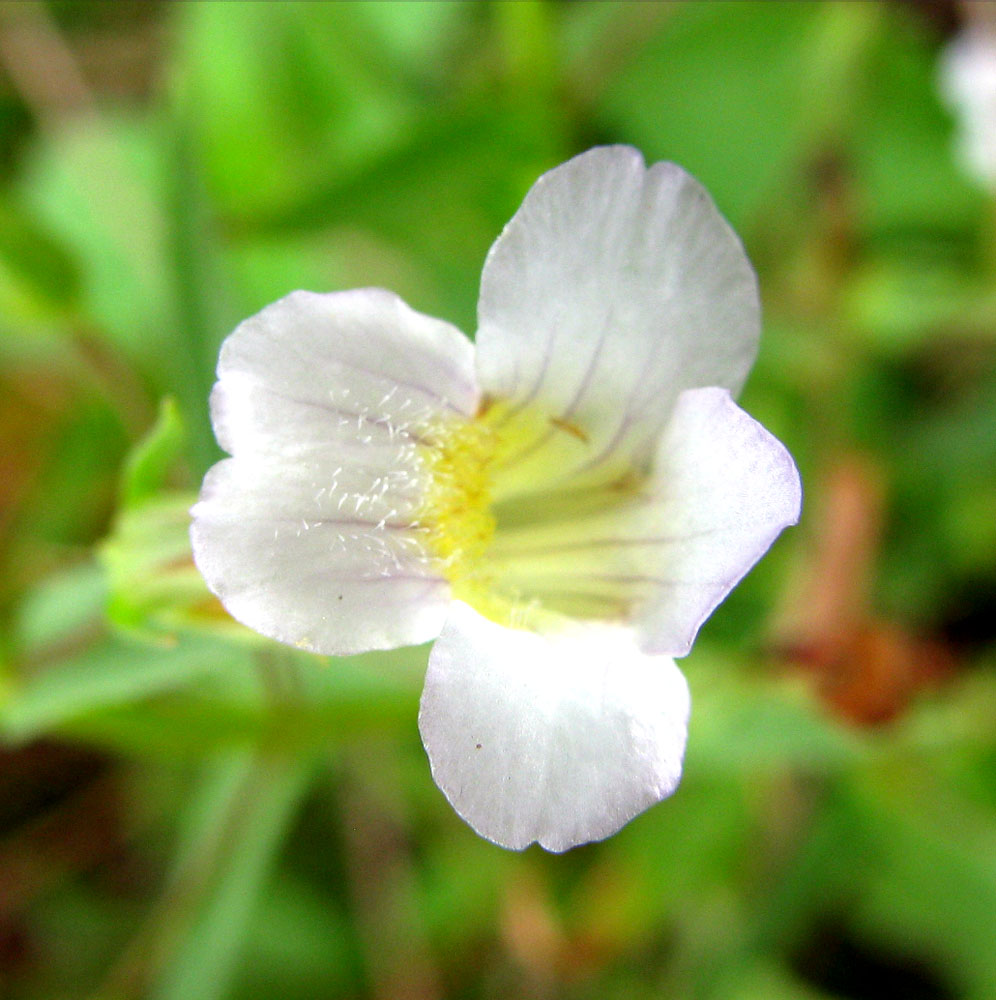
[419,601,689,851]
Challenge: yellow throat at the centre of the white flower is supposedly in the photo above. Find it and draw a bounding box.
[416,396,649,627]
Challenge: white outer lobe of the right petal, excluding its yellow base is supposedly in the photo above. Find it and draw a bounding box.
[638,388,802,656]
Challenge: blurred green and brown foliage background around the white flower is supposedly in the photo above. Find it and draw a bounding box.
[0,0,996,1000]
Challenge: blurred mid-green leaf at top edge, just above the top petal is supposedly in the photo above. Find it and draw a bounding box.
[598,2,832,225]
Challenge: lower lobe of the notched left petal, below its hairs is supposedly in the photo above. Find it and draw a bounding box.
[190,458,450,655]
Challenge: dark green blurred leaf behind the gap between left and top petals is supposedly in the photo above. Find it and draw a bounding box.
[244,103,563,333]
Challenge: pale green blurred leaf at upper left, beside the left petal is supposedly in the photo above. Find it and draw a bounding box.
[20,110,228,468]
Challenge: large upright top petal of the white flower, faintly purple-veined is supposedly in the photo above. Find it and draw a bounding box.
[477,146,759,478]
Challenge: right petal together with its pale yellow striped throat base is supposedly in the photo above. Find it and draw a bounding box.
[478,388,801,644]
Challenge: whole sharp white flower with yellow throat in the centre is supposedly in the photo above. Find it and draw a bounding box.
[192,147,800,851]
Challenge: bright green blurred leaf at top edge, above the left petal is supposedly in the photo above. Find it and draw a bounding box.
[175,3,428,216]
